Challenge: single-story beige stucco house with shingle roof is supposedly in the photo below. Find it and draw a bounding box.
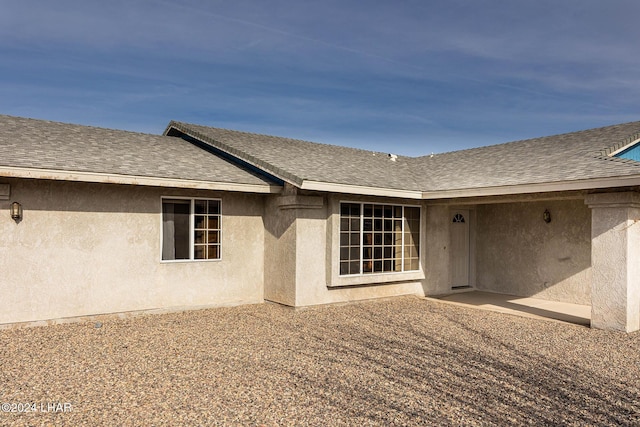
[0,116,640,332]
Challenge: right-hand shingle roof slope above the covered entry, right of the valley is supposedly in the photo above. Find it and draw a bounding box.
[410,121,640,191]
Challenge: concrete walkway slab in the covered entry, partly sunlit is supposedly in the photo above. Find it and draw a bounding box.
[432,290,591,326]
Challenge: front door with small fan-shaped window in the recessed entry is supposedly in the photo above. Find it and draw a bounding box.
[449,209,469,288]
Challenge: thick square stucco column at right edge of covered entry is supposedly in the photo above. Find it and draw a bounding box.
[585,192,640,332]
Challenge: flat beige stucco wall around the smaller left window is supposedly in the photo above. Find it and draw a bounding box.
[0,179,264,324]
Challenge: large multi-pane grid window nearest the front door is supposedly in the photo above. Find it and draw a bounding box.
[340,203,420,275]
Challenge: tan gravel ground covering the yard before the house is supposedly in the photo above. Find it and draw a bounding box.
[0,297,640,426]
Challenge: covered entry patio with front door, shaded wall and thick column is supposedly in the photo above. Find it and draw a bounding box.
[425,191,640,332]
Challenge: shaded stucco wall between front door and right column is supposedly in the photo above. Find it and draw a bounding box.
[475,199,591,305]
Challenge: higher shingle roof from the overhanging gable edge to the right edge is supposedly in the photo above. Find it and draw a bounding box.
[167,118,640,196]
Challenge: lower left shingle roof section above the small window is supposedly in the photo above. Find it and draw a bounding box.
[0,115,276,186]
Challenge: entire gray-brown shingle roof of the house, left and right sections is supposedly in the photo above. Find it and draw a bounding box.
[5,115,640,198]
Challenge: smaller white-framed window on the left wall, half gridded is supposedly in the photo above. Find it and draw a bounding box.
[162,199,221,260]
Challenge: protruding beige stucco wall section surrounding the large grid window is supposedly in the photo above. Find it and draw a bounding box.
[265,193,424,307]
